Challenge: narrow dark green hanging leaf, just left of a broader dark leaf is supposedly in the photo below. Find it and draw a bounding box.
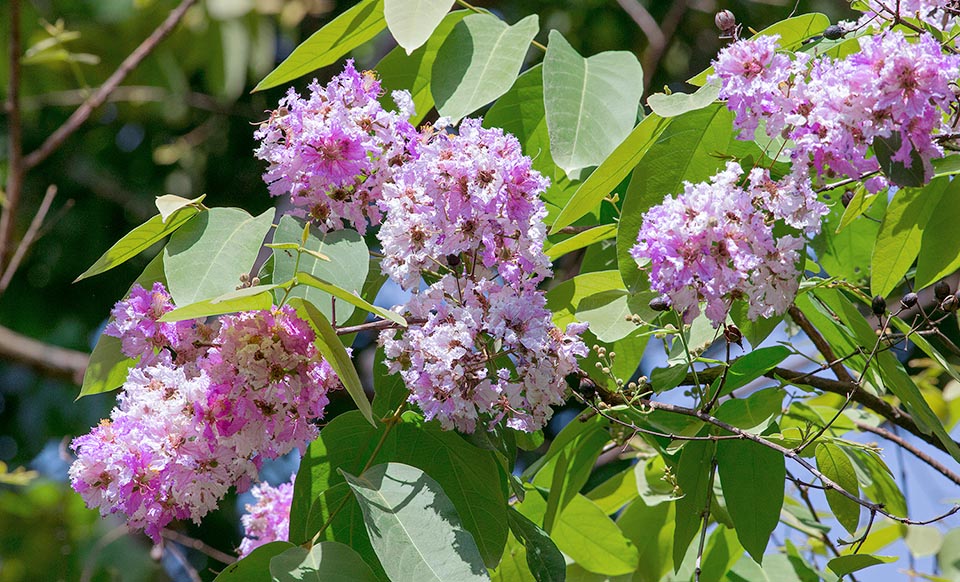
[673,441,716,572]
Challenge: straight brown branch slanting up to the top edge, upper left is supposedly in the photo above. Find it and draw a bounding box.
[23,0,197,170]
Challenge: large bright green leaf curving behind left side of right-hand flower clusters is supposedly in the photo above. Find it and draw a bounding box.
[617,103,760,290]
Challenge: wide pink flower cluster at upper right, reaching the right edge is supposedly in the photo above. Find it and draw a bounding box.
[714,31,960,192]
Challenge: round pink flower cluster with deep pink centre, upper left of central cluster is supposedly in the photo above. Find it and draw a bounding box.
[255,61,416,234]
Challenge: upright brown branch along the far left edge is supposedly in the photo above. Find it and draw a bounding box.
[0,0,26,270]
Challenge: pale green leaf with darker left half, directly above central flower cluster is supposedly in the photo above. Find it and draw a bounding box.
[430,14,540,120]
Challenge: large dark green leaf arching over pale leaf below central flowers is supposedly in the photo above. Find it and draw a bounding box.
[290,412,507,566]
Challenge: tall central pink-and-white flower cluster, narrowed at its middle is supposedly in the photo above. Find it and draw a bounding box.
[379,119,587,432]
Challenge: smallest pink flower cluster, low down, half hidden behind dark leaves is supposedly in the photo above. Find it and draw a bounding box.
[240,475,296,558]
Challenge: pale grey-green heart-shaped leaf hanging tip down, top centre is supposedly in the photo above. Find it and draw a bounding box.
[543,30,643,175]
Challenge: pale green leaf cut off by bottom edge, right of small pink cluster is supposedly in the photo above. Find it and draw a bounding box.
[270,542,377,582]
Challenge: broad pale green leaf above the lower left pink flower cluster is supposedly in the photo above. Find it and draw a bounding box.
[163,208,273,305]
